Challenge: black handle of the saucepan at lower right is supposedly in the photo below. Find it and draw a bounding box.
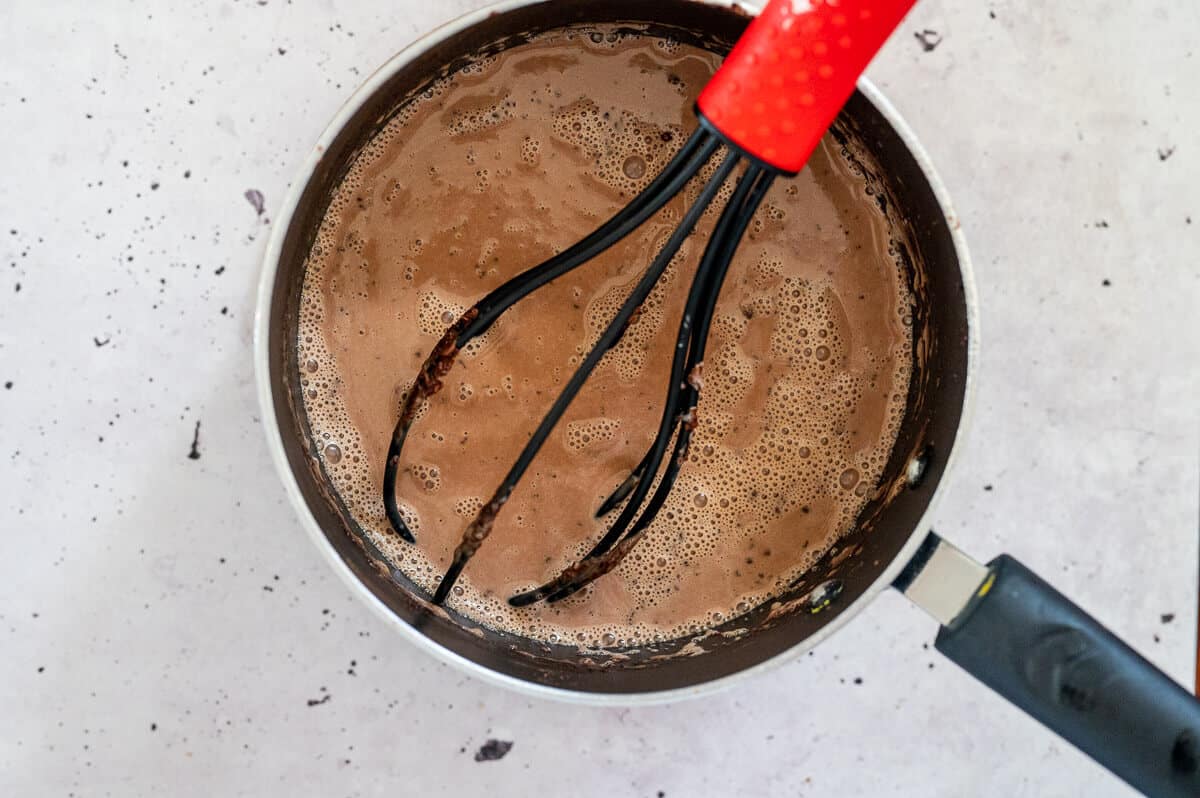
[896,535,1200,798]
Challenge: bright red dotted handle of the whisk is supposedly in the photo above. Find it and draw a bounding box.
[696,0,916,173]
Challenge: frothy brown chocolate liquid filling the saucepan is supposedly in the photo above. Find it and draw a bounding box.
[298,29,912,647]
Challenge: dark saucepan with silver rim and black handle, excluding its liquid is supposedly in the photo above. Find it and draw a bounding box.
[254,0,1200,796]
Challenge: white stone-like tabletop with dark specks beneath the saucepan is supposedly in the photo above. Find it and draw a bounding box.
[0,0,1200,798]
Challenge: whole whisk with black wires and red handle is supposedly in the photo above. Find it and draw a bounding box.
[383,0,916,606]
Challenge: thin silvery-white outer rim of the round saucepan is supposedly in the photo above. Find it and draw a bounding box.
[253,0,979,707]
